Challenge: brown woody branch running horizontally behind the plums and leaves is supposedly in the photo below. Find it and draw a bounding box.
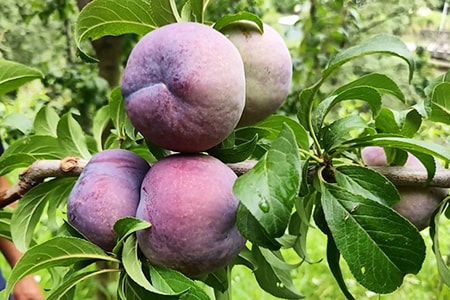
[0,156,450,208]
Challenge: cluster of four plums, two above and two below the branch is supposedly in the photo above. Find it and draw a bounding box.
[67,22,292,277]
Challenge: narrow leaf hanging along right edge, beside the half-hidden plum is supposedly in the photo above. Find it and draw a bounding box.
[430,197,450,286]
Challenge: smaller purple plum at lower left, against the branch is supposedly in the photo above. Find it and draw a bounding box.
[67,149,149,251]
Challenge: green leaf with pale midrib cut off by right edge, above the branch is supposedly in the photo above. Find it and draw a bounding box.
[428,82,450,124]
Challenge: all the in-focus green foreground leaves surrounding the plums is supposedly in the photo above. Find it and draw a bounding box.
[0,0,450,299]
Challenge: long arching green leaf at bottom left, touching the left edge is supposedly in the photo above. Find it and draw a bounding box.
[2,237,119,295]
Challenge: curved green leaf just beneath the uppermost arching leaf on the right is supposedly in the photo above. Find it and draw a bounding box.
[333,73,405,102]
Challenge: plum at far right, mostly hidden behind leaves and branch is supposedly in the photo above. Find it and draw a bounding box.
[361,146,448,230]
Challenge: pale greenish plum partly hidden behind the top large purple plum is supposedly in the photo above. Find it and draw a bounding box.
[222,22,292,126]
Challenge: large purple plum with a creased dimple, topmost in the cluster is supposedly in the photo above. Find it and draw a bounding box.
[121,22,245,152]
